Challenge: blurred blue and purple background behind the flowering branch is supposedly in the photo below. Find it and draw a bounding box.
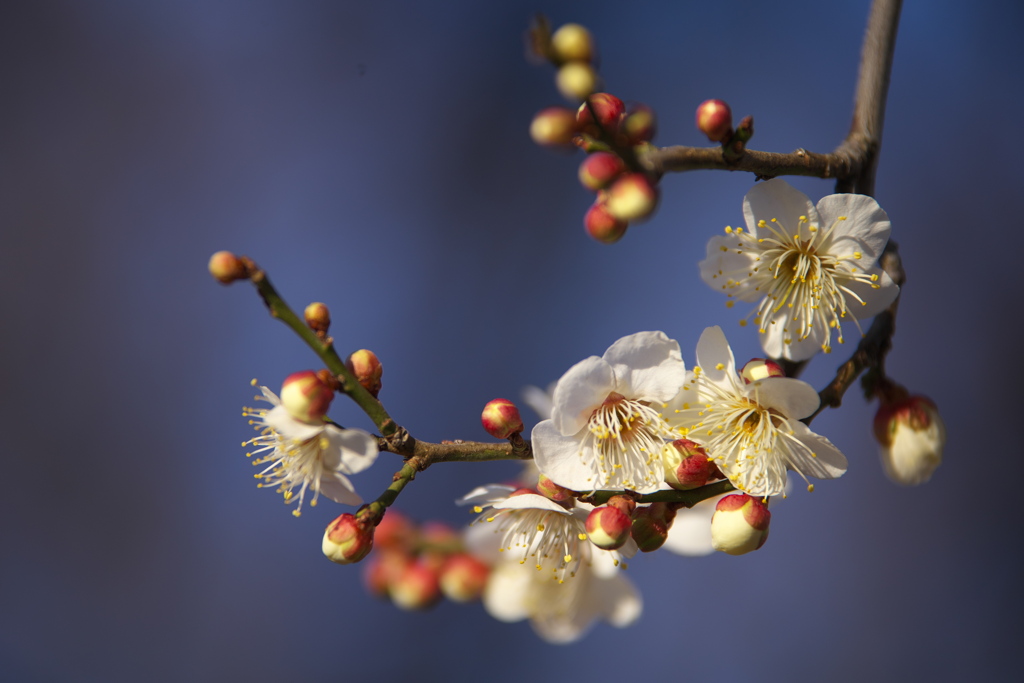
[0,0,1024,682]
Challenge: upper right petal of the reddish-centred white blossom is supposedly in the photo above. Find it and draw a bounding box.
[604,332,686,401]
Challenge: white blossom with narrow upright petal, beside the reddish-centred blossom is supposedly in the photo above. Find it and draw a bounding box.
[667,327,847,496]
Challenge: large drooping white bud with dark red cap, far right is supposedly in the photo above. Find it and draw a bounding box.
[874,395,946,486]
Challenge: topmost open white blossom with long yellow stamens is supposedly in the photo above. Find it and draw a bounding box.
[700,178,899,360]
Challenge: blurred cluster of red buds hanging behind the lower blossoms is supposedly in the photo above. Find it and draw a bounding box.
[364,509,490,609]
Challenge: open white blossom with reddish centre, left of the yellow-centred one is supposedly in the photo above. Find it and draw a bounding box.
[532,332,686,493]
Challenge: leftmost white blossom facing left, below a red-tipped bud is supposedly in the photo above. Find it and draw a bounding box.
[242,386,377,517]
